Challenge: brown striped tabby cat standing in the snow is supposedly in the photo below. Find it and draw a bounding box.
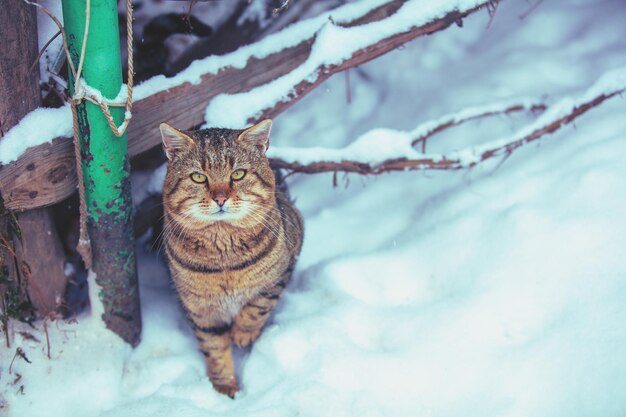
[160,119,304,398]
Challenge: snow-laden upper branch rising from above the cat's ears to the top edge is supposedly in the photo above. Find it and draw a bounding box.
[204,0,494,128]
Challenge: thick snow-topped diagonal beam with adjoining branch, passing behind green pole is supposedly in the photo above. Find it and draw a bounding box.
[0,0,493,210]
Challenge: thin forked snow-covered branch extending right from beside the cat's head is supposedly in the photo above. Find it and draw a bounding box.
[269,68,626,175]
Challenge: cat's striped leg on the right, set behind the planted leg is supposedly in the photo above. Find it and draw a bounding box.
[230,273,291,347]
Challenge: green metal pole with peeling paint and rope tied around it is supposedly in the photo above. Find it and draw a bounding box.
[63,0,141,346]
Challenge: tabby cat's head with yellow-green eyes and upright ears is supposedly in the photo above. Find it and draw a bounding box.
[160,119,275,228]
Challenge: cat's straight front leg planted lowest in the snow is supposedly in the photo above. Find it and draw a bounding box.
[193,320,239,398]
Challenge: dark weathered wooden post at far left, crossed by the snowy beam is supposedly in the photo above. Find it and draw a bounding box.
[0,1,67,318]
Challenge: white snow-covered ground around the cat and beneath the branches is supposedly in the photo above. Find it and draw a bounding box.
[0,0,626,417]
